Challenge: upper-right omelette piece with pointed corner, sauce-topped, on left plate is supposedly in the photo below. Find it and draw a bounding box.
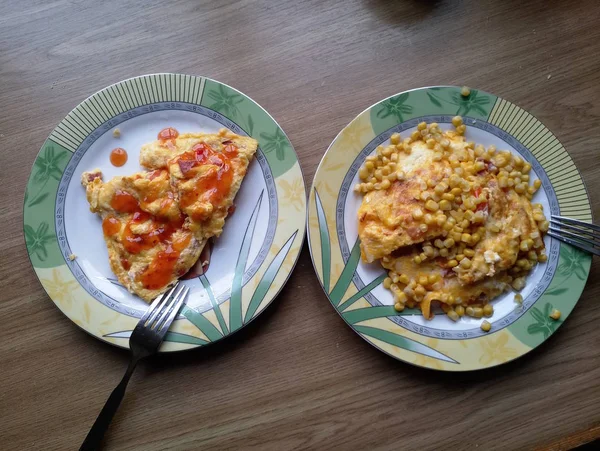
[140,129,258,240]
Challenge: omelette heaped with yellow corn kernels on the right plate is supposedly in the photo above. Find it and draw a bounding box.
[355,116,549,322]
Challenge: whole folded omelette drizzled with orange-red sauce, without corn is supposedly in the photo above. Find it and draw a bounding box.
[81,128,258,301]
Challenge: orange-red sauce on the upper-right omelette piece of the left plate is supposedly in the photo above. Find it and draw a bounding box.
[178,143,238,219]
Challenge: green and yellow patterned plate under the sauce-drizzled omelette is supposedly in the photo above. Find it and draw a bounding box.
[23,74,306,351]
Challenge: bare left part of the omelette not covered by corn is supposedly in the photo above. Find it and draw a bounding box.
[358,141,451,262]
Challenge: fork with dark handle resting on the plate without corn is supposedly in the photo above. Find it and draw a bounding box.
[79,283,189,451]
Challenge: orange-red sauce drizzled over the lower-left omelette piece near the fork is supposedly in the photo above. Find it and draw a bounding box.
[102,185,191,290]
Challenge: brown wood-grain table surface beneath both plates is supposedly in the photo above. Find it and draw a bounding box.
[0,0,600,450]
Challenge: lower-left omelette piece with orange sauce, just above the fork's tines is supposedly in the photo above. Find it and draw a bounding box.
[81,170,206,301]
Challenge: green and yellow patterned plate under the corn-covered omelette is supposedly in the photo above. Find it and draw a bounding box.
[307,86,592,371]
